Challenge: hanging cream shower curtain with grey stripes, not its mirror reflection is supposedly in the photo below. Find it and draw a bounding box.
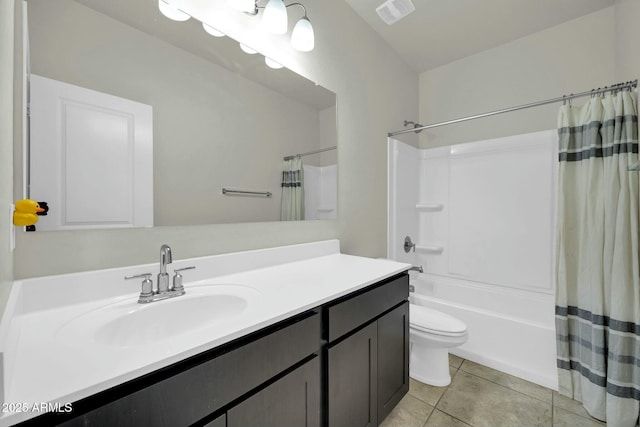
[556,90,640,427]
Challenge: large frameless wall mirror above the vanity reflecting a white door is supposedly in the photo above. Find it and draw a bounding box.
[25,0,337,231]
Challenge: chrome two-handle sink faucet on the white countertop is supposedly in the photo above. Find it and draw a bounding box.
[125,244,195,304]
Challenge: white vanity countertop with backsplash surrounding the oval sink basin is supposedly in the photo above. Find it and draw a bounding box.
[0,240,410,426]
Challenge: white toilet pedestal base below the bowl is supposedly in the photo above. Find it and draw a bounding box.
[409,342,451,387]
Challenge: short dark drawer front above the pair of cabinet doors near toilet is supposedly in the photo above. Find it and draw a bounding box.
[329,274,409,342]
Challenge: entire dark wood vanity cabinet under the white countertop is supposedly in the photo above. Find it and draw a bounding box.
[23,274,409,427]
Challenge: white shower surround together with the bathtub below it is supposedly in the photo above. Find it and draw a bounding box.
[388,130,557,389]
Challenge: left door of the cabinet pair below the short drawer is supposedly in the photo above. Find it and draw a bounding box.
[328,322,378,427]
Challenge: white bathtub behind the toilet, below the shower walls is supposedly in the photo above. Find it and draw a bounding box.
[410,273,558,390]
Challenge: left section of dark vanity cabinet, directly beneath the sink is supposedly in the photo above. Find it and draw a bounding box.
[49,310,321,427]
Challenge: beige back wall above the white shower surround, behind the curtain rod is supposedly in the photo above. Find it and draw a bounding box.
[420,5,620,147]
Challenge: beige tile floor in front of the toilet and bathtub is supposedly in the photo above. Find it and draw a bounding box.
[381,355,606,427]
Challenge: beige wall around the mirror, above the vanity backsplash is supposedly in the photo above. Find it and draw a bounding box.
[8,0,418,284]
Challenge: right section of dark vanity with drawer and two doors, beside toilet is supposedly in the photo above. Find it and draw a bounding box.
[326,275,409,427]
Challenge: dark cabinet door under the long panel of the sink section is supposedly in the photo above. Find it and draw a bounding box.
[227,357,320,427]
